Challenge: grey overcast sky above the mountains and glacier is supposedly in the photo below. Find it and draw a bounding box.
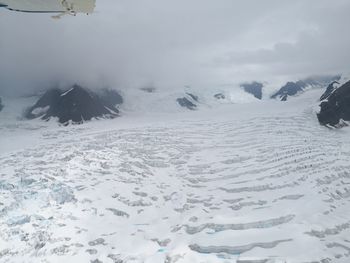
[0,0,350,95]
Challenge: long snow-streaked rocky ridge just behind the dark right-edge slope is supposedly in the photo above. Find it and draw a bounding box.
[271,75,341,101]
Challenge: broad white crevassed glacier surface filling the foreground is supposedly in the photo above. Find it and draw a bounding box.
[0,90,350,263]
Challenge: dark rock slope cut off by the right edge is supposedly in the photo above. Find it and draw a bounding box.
[317,81,350,128]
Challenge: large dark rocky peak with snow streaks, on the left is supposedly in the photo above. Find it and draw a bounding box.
[26,85,118,125]
